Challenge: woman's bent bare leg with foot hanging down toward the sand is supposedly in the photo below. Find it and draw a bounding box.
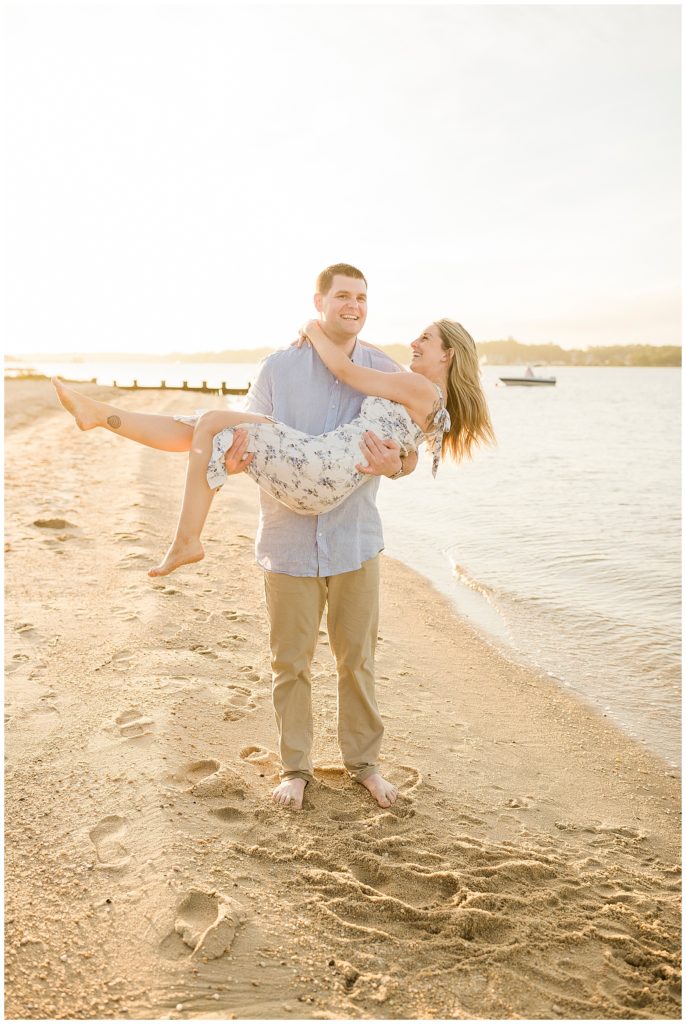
[147,412,271,577]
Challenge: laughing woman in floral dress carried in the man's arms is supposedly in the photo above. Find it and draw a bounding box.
[52,319,495,577]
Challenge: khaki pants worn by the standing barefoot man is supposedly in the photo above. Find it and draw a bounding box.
[264,555,384,782]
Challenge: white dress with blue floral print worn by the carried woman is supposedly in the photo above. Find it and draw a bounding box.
[175,388,449,515]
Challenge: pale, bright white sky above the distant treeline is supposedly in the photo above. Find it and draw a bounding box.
[3,0,680,354]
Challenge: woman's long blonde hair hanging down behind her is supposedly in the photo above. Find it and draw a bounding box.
[435,319,496,462]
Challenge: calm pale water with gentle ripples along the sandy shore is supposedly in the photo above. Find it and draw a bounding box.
[10,362,681,765]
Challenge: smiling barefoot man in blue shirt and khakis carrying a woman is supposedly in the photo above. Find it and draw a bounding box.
[226,263,417,809]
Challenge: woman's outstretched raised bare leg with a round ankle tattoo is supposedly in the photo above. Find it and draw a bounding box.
[51,377,192,452]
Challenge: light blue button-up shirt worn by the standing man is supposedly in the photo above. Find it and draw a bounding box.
[246,343,397,577]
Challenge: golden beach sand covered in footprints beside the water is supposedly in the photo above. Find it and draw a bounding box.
[5,381,681,1019]
